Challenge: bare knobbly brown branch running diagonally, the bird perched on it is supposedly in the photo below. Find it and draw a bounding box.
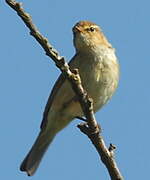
[6,0,123,180]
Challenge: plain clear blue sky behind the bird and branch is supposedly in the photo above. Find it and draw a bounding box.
[0,0,150,180]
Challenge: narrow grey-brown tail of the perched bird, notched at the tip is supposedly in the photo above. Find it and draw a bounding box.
[20,131,55,176]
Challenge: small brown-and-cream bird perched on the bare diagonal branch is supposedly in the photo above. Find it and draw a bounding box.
[20,20,120,176]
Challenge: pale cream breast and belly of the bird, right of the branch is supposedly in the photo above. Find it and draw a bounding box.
[80,48,119,111]
